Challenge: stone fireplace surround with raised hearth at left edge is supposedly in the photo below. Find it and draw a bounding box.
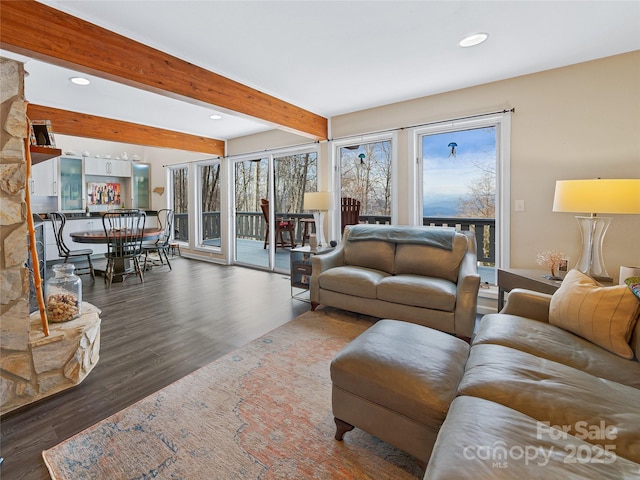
[0,58,100,415]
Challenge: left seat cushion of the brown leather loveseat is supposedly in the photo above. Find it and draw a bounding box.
[318,266,389,298]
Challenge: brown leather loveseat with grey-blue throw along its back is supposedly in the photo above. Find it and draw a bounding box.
[310,225,480,337]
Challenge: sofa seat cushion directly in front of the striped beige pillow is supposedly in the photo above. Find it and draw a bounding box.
[473,313,640,389]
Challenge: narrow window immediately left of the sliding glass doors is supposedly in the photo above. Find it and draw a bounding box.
[198,161,222,249]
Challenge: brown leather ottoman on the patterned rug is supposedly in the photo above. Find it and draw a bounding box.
[331,320,469,465]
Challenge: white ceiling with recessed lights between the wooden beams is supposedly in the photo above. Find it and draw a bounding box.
[0,0,640,139]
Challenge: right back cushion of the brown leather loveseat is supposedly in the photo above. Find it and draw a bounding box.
[394,233,467,282]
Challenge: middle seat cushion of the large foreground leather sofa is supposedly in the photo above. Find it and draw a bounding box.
[458,344,640,462]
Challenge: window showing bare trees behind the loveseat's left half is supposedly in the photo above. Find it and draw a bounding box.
[338,139,392,223]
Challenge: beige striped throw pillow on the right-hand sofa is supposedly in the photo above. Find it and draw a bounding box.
[549,270,640,359]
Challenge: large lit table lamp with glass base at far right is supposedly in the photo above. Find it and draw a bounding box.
[553,179,640,282]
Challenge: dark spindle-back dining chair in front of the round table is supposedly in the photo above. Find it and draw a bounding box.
[102,209,146,287]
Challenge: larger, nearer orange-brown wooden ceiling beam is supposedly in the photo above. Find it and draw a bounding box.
[0,0,328,140]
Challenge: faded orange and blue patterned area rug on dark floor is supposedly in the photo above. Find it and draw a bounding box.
[43,310,421,480]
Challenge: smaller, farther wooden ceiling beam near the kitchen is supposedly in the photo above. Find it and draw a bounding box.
[28,104,225,157]
